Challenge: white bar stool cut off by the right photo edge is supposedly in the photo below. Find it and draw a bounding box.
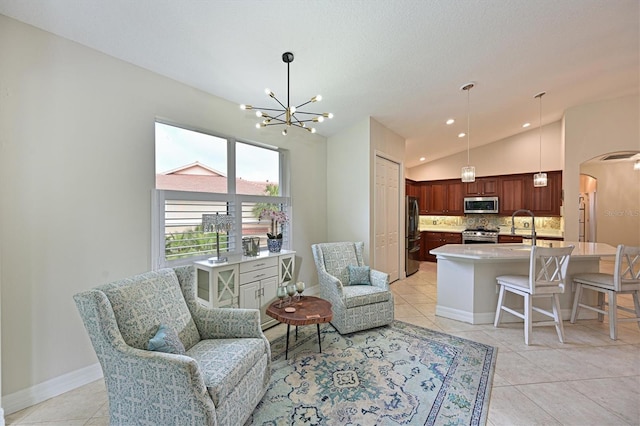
[571,244,640,340]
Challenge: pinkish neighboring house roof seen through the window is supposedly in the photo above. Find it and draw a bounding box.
[156,161,272,195]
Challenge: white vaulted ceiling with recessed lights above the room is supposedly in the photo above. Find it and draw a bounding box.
[0,0,640,167]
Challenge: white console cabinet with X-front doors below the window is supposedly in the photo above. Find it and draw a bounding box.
[194,250,296,329]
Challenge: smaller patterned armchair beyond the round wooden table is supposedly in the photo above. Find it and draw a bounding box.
[311,242,393,334]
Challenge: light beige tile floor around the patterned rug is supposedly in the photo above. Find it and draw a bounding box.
[5,262,640,426]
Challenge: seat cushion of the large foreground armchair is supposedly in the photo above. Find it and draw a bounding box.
[187,338,267,407]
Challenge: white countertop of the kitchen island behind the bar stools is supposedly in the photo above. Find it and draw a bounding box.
[429,241,616,261]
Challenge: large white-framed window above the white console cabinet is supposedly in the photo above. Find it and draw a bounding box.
[152,122,290,268]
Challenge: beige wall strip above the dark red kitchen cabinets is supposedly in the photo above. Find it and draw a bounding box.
[406,121,563,181]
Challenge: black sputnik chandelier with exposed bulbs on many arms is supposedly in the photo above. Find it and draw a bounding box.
[240,52,333,135]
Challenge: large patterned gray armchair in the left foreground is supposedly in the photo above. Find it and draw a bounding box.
[74,266,271,425]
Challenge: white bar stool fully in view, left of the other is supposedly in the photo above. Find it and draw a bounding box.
[493,246,574,345]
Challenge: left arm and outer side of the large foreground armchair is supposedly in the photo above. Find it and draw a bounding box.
[74,290,216,425]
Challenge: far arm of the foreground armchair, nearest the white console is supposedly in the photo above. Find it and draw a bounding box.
[193,305,264,339]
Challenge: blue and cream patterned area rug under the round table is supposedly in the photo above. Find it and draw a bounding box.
[247,321,497,425]
